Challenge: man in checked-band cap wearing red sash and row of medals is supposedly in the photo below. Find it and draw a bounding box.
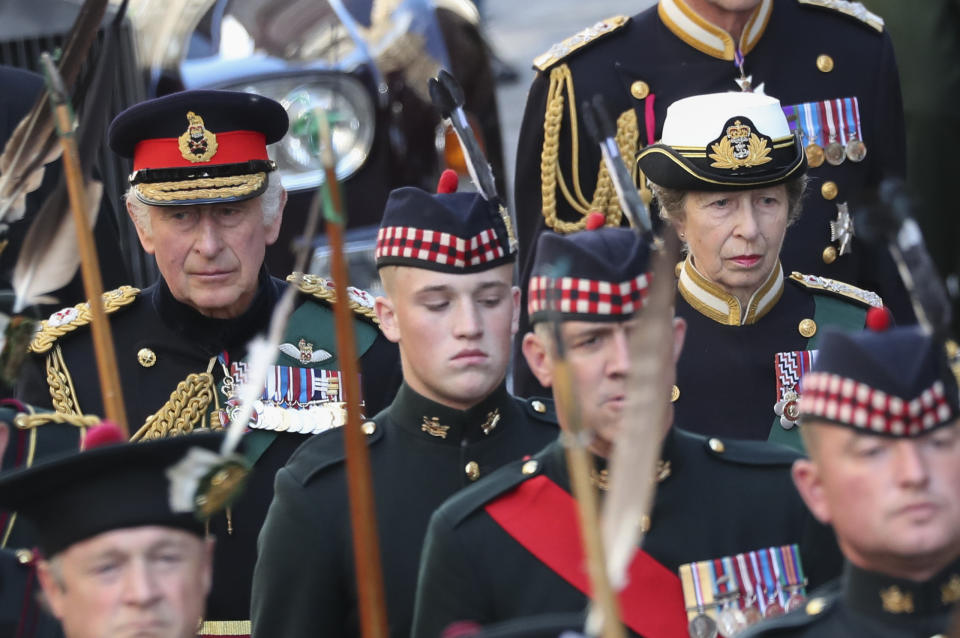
[412,228,840,638]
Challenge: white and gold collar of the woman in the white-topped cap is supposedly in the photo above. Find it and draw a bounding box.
[677,257,783,326]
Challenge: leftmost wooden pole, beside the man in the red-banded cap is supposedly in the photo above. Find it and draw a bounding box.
[41,53,130,438]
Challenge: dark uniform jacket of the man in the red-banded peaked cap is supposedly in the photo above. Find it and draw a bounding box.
[18,269,401,635]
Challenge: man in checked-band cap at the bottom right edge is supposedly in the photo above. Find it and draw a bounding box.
[751,328,960,638]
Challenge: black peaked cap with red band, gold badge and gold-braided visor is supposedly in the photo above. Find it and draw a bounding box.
[109,91,288,206]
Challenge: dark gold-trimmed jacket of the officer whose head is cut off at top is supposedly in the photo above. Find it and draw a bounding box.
[514,0,913,396]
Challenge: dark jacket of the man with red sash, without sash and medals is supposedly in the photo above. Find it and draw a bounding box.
[412,428,842,638]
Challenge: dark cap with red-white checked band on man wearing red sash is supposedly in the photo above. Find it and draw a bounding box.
[527,227,650,323]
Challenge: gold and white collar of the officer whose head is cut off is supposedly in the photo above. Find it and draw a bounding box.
[657,0,773,61]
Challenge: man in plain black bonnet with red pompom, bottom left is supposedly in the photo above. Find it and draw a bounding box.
[0,426,229,638]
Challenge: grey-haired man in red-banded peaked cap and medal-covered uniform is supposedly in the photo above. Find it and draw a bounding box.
[20,91,400,636]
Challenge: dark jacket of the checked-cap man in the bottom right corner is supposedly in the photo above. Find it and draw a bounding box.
[742,560,960,638]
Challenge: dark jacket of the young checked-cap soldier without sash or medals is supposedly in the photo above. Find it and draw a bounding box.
[251,384,558,638]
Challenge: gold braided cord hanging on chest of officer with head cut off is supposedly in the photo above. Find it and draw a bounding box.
[540,64,640,233]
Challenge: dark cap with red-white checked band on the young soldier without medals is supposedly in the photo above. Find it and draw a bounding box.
[375,186,515,273]
